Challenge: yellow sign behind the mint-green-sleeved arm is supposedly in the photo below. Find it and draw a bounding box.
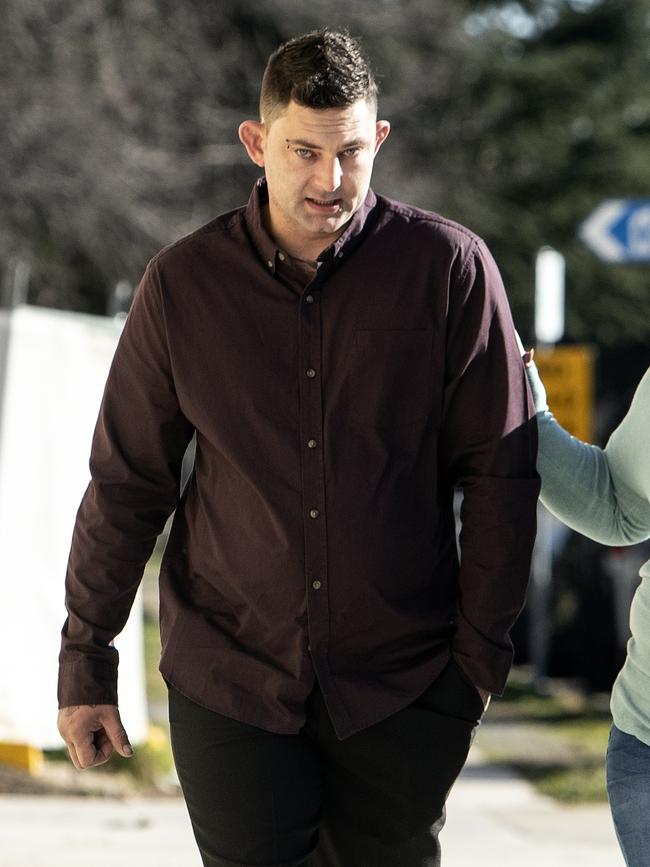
[535,344,595,442]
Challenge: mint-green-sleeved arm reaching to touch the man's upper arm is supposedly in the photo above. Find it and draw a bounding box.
[526,361,650,545]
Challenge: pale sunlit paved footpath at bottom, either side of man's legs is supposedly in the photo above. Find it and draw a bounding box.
[0,752,623,867]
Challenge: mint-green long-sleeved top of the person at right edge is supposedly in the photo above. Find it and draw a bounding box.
[528,366,650,745]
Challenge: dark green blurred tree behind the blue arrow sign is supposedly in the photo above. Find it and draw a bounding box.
[445,0,650,346]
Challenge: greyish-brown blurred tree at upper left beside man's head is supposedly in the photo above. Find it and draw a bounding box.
[0,0,462,312]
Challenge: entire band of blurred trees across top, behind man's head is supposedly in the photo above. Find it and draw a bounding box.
[0,0,650,345]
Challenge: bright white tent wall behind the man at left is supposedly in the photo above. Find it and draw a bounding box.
[0,305,147,748]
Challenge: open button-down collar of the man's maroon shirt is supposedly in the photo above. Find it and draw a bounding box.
[246,178,377,274]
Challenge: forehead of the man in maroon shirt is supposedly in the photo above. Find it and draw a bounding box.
[270,99,376,145]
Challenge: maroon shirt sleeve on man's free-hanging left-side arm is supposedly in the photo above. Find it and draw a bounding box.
[59,259,192,707]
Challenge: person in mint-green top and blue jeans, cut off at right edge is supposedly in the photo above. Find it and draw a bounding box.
[524,351,650,867]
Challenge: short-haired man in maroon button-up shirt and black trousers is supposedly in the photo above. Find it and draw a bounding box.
[60,31,538,867]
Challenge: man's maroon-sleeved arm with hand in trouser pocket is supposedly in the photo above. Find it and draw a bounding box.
[441,243,539,693]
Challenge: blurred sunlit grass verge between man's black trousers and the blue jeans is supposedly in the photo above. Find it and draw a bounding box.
[477,671,611,804]
